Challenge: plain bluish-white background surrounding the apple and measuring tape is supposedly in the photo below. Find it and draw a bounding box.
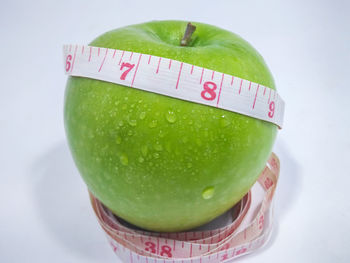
[0,0,350,263]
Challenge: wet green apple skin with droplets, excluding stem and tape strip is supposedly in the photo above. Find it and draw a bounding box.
[64,21,277,232]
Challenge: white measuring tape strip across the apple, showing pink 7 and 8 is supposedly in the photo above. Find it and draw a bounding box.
[63,45,284,128]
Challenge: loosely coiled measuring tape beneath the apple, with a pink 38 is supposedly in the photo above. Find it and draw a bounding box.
[90,153,280,263]
